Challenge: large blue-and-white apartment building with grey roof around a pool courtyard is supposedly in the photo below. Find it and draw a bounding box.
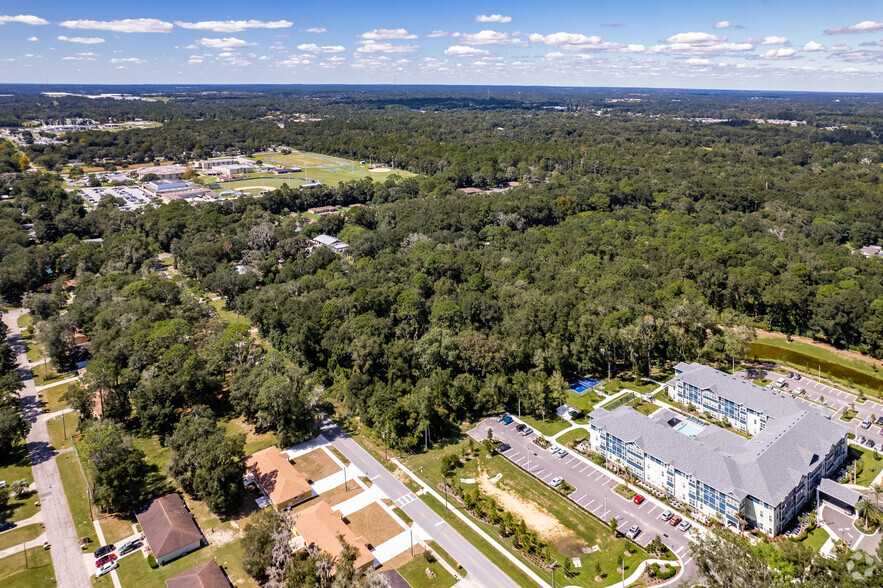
[590,364,847,535]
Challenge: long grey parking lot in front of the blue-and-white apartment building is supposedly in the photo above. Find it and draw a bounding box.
[469,418,695,578]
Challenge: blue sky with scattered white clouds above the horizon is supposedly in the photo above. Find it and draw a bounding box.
[0,0,883,92]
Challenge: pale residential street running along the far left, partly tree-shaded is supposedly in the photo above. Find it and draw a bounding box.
[3,309,92,588]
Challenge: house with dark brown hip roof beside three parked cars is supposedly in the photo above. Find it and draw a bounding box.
[135,492,202,565]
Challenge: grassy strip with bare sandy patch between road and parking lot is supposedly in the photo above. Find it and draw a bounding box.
[406,434,646,586]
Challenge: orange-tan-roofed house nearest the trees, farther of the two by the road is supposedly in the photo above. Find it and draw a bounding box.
[245,447,313,510]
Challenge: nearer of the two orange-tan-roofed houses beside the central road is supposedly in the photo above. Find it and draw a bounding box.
[292,500,374,572]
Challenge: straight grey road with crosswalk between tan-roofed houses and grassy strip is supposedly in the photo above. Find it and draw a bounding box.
[322,421,518,588]
